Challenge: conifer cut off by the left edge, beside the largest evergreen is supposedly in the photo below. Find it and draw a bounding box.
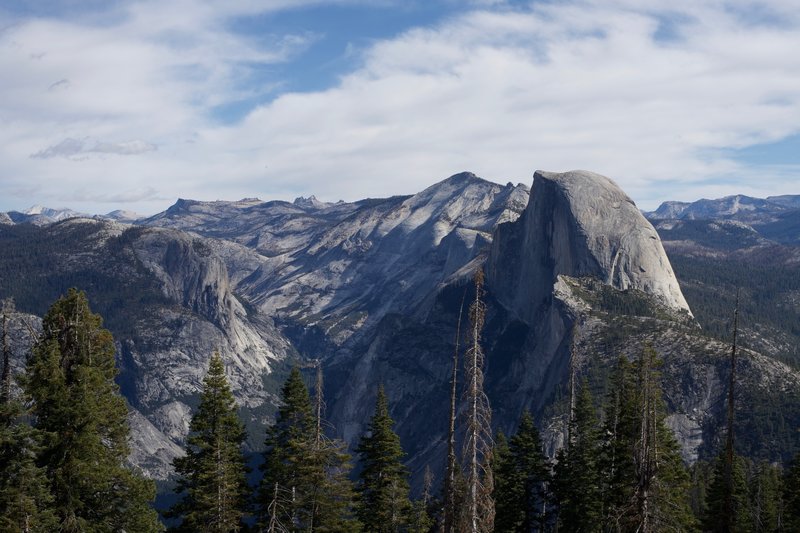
[0,307,58,533]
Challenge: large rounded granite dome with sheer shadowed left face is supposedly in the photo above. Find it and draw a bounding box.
[487,170,689,323]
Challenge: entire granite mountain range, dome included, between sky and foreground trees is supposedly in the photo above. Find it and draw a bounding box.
[0,171,800,486]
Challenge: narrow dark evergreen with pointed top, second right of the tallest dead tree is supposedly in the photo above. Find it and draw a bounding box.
[554,379,602,533]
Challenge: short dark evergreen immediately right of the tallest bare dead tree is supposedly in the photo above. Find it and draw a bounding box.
[495,411,550,533]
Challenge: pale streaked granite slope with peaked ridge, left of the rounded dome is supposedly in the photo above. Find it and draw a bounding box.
[146,172,528,344]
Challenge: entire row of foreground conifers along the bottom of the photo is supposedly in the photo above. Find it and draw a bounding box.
[0,280,800,533]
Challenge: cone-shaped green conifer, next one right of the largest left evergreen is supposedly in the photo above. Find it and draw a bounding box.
[168,352,249,533]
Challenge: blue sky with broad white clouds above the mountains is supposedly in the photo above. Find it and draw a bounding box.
[0,0,800,215]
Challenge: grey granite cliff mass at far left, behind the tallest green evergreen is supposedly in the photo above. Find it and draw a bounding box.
[0,219,296,479]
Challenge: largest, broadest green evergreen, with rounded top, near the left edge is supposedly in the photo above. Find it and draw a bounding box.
[24,289,163,533]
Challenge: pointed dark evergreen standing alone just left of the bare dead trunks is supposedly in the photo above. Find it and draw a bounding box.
[357,386,410,533]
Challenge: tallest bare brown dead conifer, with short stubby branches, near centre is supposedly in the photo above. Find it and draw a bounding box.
[459,270,494,533]
